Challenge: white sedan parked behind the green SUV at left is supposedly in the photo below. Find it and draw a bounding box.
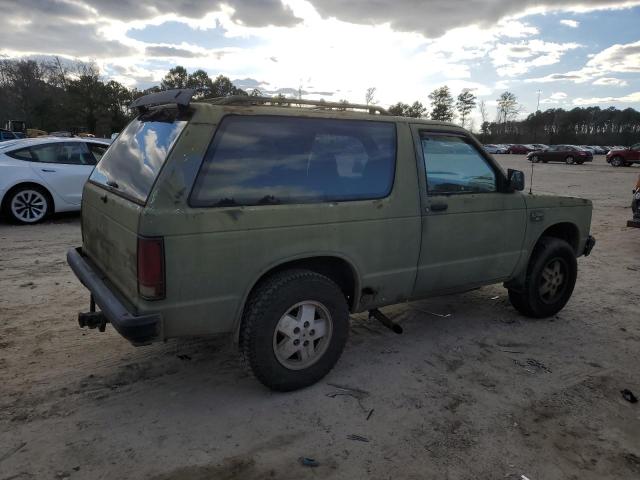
[0,137,109,223]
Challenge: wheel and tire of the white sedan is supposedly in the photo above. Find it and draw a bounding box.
[2,184,53,225]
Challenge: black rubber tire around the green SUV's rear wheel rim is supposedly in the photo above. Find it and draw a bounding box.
[240,270,349,392]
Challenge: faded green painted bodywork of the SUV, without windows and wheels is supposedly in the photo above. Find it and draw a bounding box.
[83,104,591,338]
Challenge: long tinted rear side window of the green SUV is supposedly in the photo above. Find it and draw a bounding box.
[191,116,396,207]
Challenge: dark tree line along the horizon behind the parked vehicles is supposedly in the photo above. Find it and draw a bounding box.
[0,57,640,145]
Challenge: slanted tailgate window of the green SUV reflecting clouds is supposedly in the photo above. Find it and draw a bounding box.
[89,108,187,203]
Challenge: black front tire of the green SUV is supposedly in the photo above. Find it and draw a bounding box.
[509,237,578,318]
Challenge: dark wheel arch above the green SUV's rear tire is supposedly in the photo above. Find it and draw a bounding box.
[234,253,360,342]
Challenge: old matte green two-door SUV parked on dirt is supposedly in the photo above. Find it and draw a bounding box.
[67,90,594,391]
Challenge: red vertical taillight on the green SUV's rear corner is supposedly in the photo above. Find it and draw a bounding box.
[138,237,165,300]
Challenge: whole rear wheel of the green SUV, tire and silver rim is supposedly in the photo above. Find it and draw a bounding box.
[240,270,349,392]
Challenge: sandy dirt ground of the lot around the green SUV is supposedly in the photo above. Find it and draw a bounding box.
[0,155,640,480]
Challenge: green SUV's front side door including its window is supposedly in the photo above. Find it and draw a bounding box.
[413,129,526,297]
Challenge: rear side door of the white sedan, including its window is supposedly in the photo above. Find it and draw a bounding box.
[30,142,96,205]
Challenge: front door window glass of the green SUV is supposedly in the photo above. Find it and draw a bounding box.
[421,133,497,195]
